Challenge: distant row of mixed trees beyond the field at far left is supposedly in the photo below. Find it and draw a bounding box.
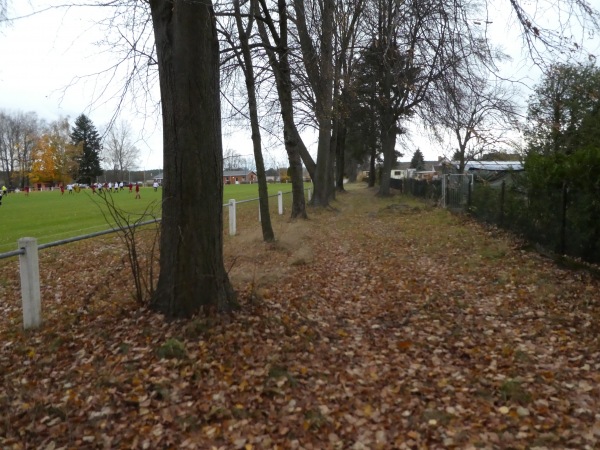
[0,111,138,188]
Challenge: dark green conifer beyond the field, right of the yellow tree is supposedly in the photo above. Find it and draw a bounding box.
[71,114,102,184]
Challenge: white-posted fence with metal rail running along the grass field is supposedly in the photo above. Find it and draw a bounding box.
[0,189,311,330]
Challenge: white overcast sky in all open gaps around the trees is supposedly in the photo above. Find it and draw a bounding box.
[0,0,596,169]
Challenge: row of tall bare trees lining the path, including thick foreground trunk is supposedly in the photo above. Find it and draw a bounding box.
[5,0,598,317]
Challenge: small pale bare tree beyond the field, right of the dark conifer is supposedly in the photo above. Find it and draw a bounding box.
[103,120,140,180]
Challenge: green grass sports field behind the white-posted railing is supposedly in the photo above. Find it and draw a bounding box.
[0,184,291,253]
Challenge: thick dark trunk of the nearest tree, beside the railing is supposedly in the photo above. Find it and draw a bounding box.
[150,0,235,318]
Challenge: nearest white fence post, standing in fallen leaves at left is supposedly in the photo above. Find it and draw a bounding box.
[19,238,42,330]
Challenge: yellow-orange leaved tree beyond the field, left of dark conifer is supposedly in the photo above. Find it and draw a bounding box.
[29,119,82,185]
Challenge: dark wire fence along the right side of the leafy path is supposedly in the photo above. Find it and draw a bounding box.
[392,172,600,264]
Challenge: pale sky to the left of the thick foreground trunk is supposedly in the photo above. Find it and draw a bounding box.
[0,0,162,169]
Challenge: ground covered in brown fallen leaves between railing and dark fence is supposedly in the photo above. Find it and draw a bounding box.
[0,185,600,449]
